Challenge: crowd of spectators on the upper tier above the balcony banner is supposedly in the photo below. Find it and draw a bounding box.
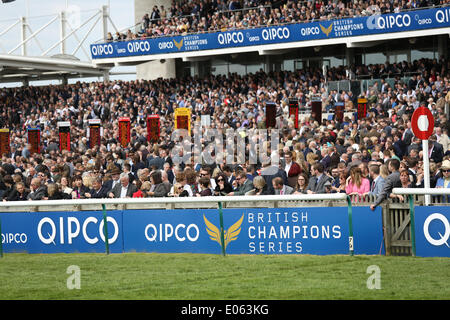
[107,0,449,41]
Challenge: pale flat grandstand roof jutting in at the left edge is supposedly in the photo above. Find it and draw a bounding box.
[0,54,109,83]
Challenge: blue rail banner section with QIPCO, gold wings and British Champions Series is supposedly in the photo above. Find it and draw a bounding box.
[123,207,384,255]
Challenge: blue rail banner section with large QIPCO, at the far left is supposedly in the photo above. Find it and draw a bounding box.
[0,211,123,253]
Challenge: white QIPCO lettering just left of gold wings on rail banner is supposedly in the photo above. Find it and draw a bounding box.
[144,223,200,242]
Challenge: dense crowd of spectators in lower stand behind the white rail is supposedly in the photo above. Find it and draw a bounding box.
[0,59,450,206]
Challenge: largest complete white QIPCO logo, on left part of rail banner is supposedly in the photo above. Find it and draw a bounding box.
[37,217,119,245]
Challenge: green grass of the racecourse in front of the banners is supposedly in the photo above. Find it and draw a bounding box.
[0,253,450,300]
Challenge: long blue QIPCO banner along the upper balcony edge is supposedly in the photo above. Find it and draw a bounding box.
[90,7,450,59]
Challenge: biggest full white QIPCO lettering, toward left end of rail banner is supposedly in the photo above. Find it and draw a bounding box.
[37,217,119,245]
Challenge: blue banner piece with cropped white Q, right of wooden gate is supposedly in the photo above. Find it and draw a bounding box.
[414,206,450,257]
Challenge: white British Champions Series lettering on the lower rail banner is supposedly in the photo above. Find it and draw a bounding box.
[247,211,342,253]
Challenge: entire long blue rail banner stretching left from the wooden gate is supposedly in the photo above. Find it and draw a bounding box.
[0,207,384,255]
